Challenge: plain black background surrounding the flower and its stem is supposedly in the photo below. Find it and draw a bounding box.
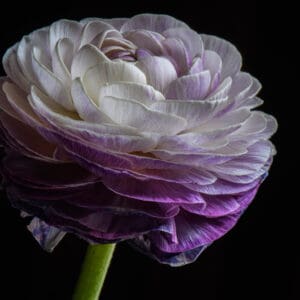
[0,0,300,300]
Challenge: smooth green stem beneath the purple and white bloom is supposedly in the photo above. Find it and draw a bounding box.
[72,244,116,300]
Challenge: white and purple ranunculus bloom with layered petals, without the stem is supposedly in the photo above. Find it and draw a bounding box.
[0,14,276,265]
